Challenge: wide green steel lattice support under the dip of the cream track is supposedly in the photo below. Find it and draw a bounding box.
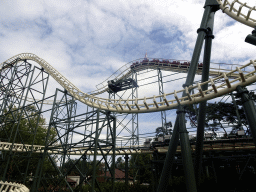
[40,89,116,191]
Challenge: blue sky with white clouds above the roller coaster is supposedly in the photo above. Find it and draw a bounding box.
[0,0,256,144]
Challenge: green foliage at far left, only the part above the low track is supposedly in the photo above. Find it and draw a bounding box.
[0,106,57,145]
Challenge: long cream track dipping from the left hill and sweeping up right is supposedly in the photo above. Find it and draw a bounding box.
[0,53,256,113]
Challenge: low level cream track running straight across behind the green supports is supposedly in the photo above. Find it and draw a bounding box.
[0,140,256,155]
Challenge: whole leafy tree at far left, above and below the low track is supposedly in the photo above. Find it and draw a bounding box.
[0,105,57,181]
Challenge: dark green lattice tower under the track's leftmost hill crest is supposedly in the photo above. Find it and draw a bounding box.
[0,59,49,188]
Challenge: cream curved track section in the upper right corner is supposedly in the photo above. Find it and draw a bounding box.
[217,0,256,28]
